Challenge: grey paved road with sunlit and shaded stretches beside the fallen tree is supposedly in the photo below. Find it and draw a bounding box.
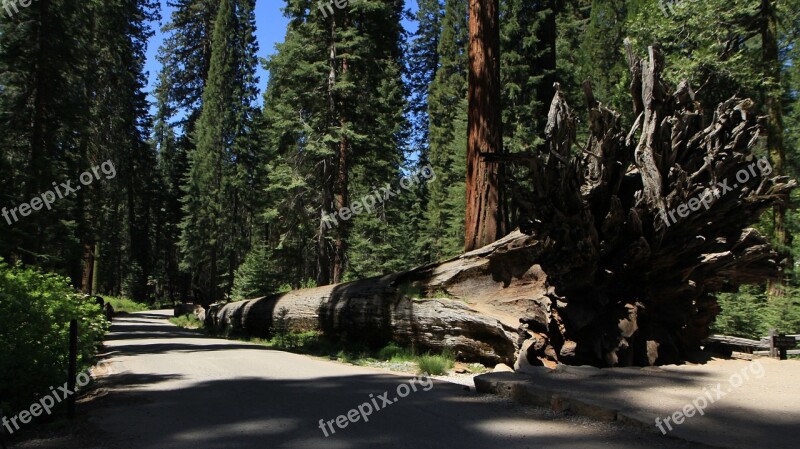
[90,312,700,449]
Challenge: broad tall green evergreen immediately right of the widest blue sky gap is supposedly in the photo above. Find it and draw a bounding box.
[262,0,408,285]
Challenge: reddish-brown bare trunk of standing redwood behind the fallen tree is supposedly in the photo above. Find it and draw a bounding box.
[464,0,505,251]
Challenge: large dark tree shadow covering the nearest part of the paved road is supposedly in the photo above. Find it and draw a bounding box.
[86,375,695,449]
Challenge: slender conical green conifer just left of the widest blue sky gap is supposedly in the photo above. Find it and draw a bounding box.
[180,0,257,301]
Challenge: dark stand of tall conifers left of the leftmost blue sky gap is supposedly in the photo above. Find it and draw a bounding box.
[0,0,159,299]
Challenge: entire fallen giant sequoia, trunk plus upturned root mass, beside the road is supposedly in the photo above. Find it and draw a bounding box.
[207,45,795,366]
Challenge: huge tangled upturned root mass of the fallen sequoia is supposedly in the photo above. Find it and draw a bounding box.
[498,45,796,366]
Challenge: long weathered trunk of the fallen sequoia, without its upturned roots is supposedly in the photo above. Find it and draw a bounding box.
[202,228,552,366]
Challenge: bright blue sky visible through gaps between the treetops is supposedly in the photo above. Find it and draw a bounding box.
[145,0,417,110]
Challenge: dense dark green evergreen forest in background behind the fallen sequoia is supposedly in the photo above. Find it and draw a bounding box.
[0,0,800,333]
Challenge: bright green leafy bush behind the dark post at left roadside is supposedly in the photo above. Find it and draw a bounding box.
[0,259,108,413]
